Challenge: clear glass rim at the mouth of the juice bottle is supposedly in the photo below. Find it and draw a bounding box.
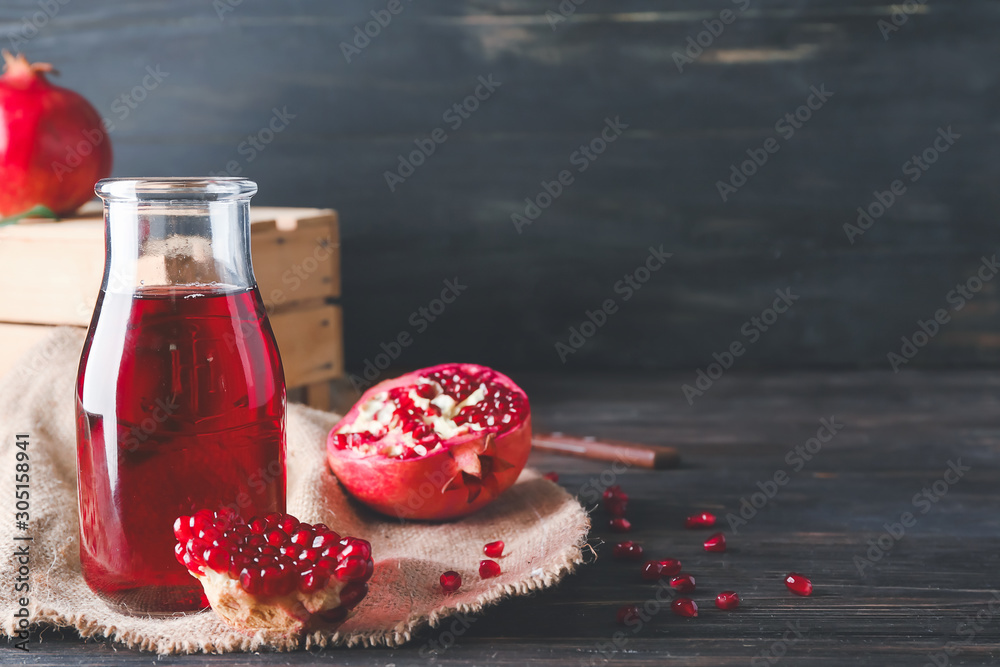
[94,177,257,202]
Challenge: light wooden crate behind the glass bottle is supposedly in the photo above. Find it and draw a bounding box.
[0,205,344,409]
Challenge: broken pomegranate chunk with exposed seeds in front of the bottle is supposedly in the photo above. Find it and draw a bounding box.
[174,510,374,635]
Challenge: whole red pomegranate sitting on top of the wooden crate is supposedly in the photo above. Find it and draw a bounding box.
[0,51,111,218]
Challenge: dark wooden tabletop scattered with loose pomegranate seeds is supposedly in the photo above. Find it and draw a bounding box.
[9,371,1000,667]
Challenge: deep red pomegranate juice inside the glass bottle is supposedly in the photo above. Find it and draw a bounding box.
[76,287,285,614]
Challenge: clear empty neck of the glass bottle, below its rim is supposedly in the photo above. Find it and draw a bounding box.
[102,197,255,293]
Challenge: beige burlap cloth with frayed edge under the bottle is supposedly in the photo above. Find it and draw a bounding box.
[0,328,589,654]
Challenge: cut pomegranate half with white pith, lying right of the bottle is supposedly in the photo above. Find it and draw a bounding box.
[327,364,531,519]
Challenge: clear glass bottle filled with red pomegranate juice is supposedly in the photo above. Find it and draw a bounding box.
[76,178,285,614]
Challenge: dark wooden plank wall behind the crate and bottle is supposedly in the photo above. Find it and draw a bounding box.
[0,0,1000,370]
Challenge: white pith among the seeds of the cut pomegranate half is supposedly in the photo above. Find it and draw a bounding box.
[338,378,487,457]
